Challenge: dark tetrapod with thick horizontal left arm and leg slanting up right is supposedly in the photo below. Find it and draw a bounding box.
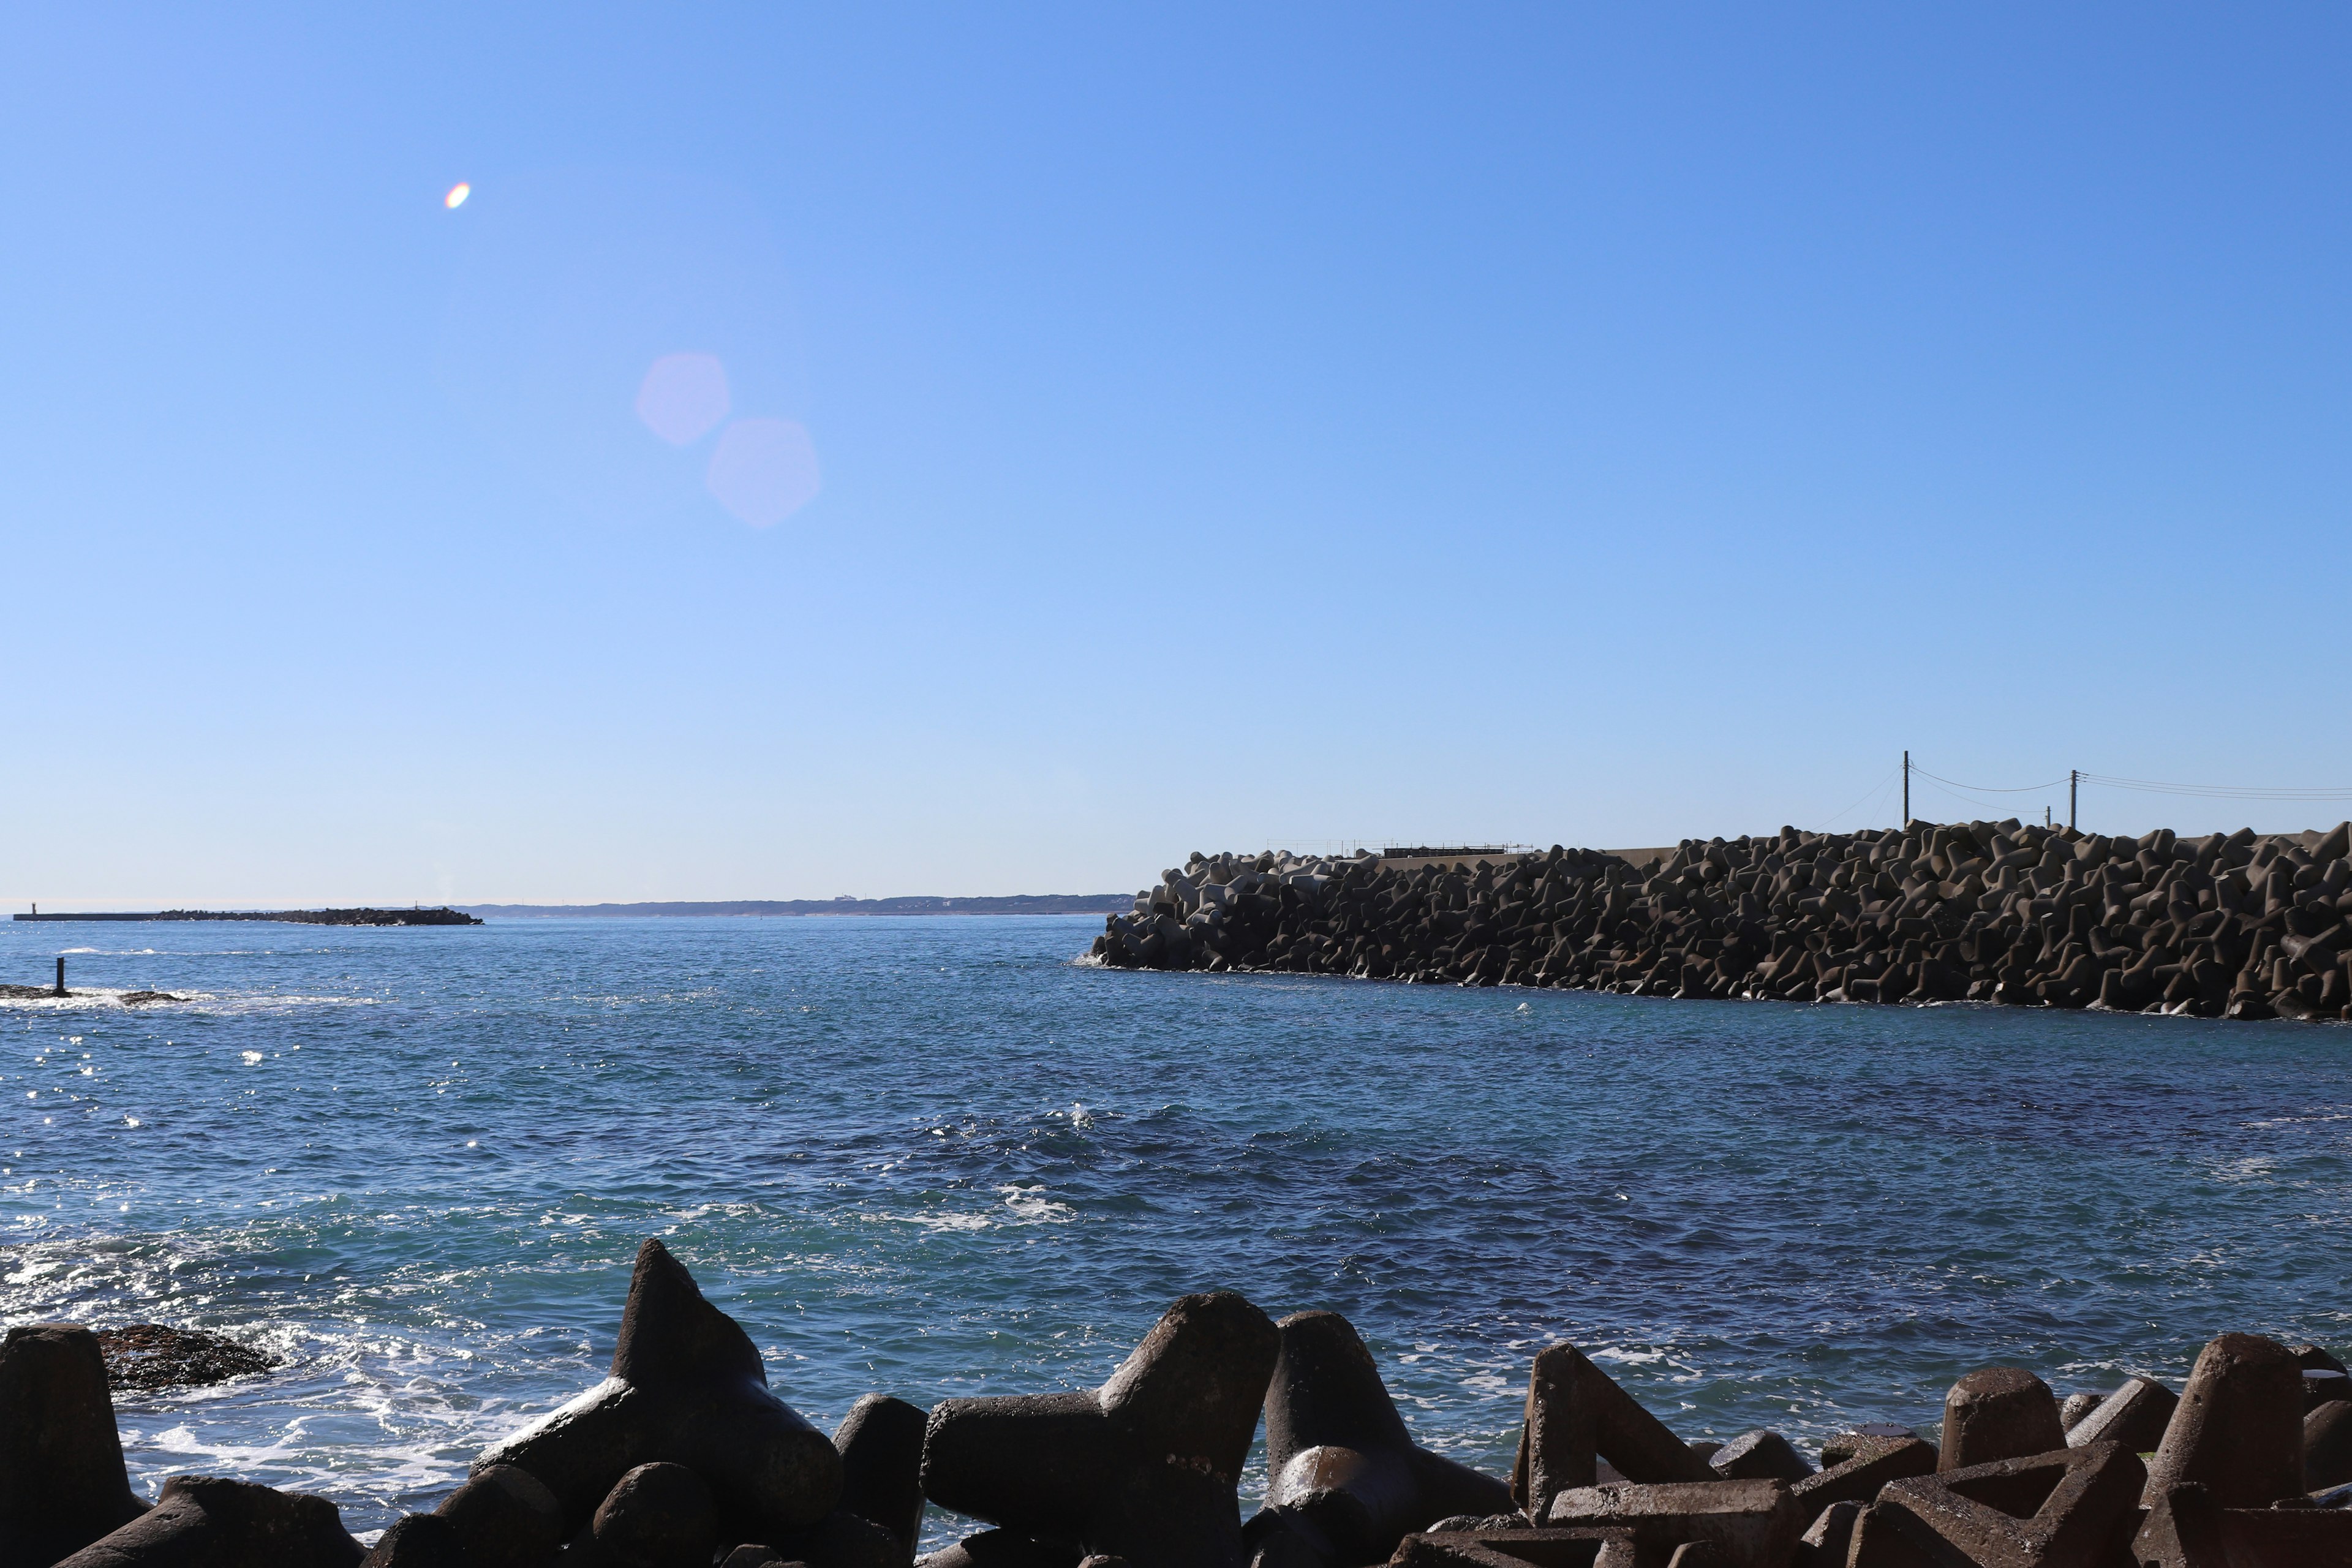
[922,1291,1282,1568]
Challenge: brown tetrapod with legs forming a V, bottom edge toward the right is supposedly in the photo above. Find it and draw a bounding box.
[1877,1444,2147,1568]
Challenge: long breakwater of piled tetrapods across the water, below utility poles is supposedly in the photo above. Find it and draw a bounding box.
[1089,820,2352,1020]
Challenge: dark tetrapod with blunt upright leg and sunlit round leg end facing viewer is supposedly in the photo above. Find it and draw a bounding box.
[1242,1312,1512,1568]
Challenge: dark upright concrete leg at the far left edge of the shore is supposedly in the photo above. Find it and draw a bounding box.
[0,1324,146,1568]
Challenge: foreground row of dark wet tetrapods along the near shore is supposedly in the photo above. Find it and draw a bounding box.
[13,1242,2352,1568]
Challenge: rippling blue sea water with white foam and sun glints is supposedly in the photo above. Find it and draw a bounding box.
[0,919,2352,1537]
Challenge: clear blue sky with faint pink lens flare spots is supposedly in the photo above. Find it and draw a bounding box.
[0,5,2352,907]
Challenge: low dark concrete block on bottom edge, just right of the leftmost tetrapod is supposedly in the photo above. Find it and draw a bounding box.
[59,1476,367,1568]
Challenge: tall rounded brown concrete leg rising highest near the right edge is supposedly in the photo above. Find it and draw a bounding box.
[2143,1333,2305,1509]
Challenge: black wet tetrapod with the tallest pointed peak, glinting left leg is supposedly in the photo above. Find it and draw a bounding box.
[473,1242,842,1540]
